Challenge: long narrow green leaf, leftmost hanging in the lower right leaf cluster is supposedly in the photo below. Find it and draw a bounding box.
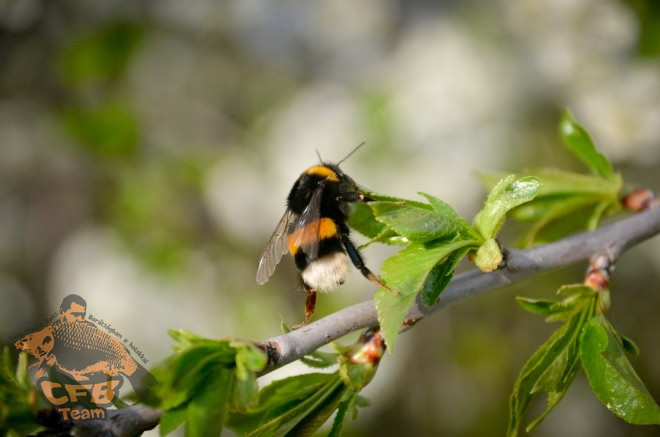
[508,299,593,437]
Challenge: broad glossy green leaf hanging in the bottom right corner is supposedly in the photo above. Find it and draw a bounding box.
[580,315,660,425]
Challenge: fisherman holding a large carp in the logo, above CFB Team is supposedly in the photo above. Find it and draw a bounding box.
[15,294,156,397]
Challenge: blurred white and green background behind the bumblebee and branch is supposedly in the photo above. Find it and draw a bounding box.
[0,0,660,436]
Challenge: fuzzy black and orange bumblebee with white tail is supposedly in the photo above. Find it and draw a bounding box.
[257,144,389,329]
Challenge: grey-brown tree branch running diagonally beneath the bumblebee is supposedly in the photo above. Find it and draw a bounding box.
[59,207,660,436]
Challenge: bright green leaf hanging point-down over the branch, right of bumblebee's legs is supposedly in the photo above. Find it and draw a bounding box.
[374,240,474,354]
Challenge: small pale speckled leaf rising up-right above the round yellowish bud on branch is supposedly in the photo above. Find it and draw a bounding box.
[474,175,541,239]
